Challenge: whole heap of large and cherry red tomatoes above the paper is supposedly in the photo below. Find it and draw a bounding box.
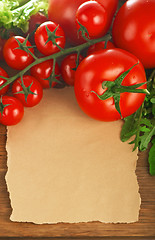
[0,0,155,125]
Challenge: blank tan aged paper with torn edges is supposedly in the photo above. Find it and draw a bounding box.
[6,87,140,224]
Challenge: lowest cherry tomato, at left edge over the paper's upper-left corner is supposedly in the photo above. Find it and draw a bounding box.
[0,96,24,126]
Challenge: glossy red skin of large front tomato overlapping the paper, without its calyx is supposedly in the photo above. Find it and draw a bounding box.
[74,48,146,121]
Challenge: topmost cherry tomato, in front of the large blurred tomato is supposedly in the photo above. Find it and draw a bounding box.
[76,1,107,38]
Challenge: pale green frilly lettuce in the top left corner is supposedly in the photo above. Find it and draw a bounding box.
[0,0,48,32]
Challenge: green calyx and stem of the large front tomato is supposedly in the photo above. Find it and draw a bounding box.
[91,62,150,117]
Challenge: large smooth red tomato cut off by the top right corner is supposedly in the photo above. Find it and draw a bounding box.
[112,0,155,68]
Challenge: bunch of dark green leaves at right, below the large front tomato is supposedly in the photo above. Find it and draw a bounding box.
[121,69,155,175]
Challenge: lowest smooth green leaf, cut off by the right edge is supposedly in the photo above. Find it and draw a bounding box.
[148,137,155,176]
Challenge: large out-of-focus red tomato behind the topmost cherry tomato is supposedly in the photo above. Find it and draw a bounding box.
[48,0,118,44]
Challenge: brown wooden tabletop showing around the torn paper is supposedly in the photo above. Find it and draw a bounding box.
[0,125,155,240]
